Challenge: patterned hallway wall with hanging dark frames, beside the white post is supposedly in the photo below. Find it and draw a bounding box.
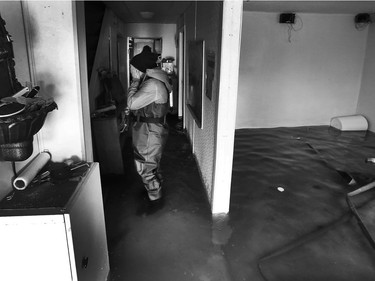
[185,1,222,203]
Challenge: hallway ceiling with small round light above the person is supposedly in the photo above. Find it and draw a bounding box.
[103,1,193,23]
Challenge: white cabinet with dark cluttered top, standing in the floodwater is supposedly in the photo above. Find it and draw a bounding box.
[0,163,109,281]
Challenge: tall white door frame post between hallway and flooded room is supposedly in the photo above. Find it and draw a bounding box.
[211,0,243,214]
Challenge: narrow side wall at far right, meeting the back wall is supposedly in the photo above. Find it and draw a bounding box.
[357,21,375,132]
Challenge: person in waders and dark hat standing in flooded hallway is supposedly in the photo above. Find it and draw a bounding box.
[127,47,172,202]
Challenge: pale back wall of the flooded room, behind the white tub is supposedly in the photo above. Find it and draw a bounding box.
[236,12,367,128]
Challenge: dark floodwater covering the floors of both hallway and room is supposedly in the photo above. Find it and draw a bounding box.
[103,121,375,281]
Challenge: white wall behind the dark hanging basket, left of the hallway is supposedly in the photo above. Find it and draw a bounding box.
[23,1,85,162]
